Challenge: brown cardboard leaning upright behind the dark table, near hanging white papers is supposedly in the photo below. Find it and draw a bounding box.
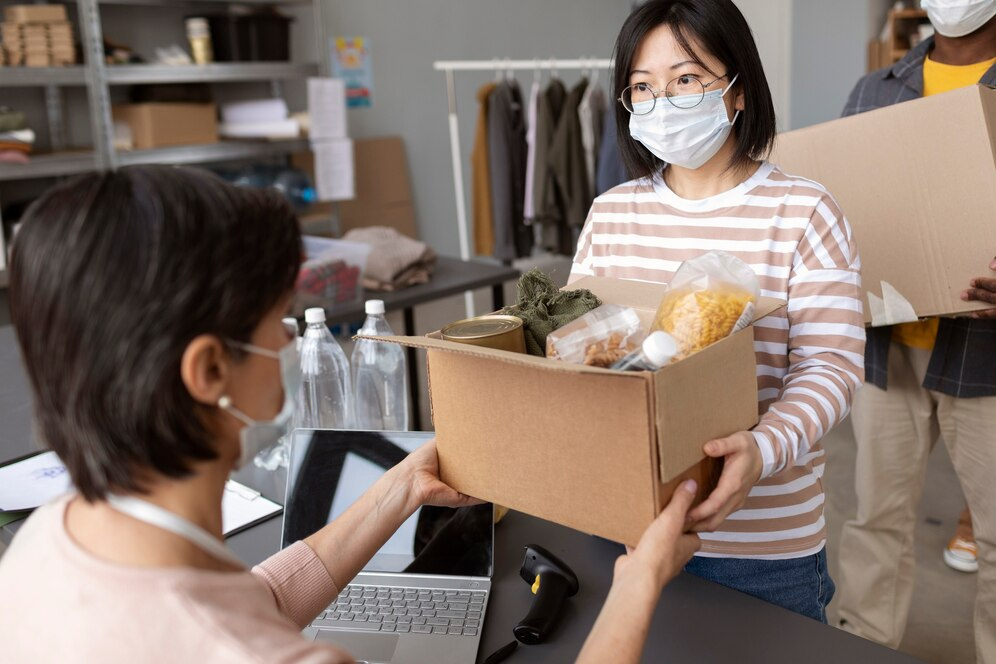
[293,136,418,239]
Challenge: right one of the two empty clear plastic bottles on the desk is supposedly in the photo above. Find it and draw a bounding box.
[353,300,408,431]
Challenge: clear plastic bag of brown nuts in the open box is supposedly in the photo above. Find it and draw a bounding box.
[546,304,646,367]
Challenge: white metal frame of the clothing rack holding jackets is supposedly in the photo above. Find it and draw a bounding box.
[432,58,613,318]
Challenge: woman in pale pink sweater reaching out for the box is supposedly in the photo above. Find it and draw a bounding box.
[0,167,698,664]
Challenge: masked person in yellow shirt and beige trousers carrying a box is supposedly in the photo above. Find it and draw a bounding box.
[840,0,996,664]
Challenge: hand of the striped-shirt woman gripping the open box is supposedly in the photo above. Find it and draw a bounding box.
[687,431,764,532]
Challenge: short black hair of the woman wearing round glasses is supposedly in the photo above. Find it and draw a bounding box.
[614,0,776,178]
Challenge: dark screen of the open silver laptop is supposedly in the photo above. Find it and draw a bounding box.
[282,429,494,577]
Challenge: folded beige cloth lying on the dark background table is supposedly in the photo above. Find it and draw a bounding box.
[342,226,436,291]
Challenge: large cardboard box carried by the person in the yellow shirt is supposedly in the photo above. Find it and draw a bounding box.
[771,86,996,325]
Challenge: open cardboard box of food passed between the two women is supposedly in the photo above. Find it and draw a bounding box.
[372,277,784,545]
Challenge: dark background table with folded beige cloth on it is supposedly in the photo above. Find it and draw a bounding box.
[293,256,519,431]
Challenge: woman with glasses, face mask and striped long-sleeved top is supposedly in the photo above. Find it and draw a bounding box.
[572,0,864,622]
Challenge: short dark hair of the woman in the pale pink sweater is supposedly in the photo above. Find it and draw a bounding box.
[10,166,301,501]
